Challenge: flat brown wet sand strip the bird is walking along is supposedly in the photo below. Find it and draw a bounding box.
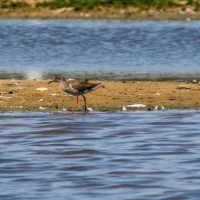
[0,80,200,112]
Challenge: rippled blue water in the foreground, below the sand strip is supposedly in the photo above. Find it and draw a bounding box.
[0,110,200,200]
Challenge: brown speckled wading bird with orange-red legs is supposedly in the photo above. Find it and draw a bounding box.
[48,75,102,113]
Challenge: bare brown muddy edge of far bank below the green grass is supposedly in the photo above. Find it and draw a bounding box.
[0,7,200,21]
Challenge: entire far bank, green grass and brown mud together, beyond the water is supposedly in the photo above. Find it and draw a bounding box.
[0,0,200,20]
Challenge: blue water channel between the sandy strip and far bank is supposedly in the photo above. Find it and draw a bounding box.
[0,20,200,79]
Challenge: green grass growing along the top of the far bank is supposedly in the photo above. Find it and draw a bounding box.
[36,0,200,10]
